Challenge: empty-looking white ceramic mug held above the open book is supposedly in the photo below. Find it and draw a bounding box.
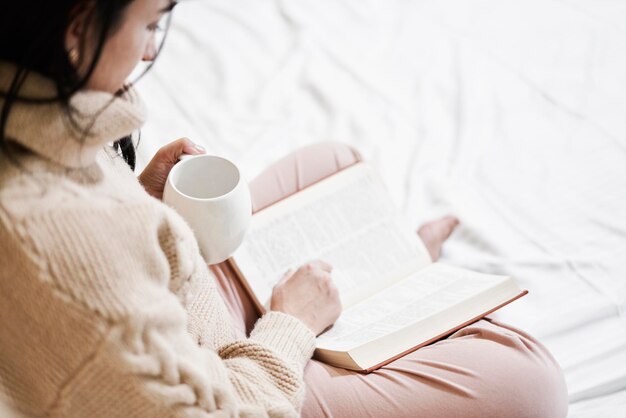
[163,155,252,264]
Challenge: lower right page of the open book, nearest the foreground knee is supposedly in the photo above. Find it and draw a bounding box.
[317,263,510,351]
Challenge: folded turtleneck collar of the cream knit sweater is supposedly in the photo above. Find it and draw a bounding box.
[0,62,146,168]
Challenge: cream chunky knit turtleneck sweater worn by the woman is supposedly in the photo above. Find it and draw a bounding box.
[0,64,315,418]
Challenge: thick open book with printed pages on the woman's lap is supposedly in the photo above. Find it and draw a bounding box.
[230,163,527,372]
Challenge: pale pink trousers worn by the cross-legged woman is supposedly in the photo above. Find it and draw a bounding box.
[211,142,567,418]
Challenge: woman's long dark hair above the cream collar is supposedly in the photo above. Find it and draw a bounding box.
[0,0,171,170]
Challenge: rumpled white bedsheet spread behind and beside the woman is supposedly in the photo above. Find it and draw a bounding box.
[139,0,626,417]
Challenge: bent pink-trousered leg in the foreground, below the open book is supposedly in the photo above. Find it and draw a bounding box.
[303,321,567,418]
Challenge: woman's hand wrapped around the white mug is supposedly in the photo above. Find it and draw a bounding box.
[139,138,206,200]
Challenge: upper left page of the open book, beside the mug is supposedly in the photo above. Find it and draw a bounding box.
[233,164,430,307]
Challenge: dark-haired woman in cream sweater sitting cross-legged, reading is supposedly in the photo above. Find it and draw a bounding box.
[0,0,566,417]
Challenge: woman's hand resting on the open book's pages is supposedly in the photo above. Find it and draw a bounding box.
[270,260,341,335]
